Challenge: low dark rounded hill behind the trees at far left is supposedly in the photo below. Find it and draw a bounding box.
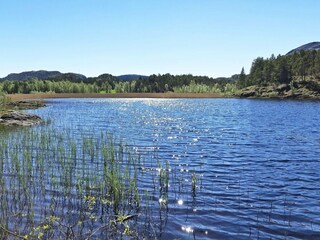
[1,70,86,81]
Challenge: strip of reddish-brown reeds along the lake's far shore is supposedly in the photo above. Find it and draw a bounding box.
[7,93,225,101]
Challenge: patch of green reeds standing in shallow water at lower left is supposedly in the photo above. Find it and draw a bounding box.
[0,128,197,239]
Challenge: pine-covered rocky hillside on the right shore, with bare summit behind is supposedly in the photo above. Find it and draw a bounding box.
[237,42,320,99]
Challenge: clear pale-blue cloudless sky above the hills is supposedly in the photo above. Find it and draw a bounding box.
[0,0,320,77]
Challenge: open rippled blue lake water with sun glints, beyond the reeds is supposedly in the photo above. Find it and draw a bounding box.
[27,99,320,239]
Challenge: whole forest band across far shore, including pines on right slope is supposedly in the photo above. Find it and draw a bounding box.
[0,51,320,95]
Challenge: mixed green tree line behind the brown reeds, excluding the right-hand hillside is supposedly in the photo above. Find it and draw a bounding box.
[0,74,237,94]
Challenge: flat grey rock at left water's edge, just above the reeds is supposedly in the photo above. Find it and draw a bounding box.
[0,111,42,126]
